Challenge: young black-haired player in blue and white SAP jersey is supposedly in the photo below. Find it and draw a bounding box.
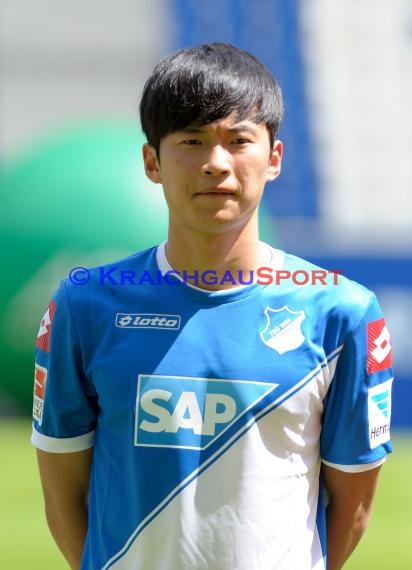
[32,43,392,570]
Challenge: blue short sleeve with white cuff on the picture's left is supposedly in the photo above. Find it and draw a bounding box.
[32,282,97,453]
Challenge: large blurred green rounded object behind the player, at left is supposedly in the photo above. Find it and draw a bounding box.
[0,121,167,414]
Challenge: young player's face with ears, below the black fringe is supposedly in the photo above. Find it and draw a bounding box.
[143,117,282,233]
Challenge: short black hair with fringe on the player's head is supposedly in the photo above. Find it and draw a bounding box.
[140,43,283,156]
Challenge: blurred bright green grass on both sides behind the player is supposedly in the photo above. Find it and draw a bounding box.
[0,420,412,570]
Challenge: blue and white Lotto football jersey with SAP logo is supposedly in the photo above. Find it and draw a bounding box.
[32,246,392,570]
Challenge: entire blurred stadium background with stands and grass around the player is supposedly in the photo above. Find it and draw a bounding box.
[0,0,412,570]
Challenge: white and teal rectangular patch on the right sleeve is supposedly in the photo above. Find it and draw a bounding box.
[368,378,393,449]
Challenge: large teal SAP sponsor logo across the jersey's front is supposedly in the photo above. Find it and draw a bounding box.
[135,374,278,449]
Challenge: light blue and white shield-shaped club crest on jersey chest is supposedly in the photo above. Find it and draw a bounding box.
[260,305,306,354]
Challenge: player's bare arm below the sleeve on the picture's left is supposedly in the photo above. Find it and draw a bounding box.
[37,448,93,570]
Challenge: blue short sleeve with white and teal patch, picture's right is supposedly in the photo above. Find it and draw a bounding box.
[320,296,393,472]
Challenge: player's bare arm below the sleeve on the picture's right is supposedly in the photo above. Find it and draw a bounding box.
[322,465,380,570]
